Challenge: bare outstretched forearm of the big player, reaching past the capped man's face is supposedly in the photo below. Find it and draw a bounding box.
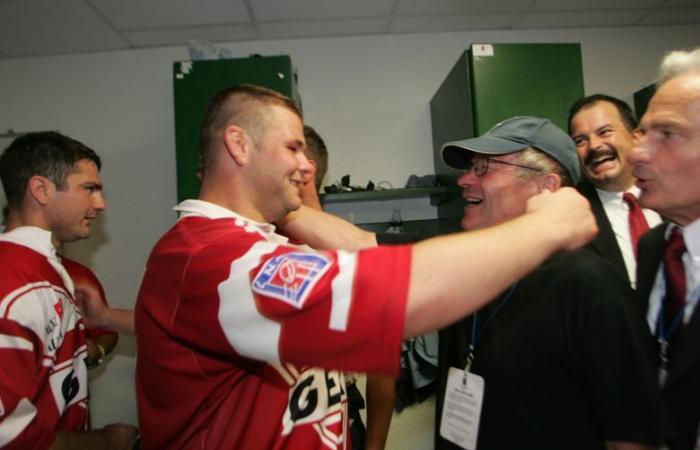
[404,197,596,337]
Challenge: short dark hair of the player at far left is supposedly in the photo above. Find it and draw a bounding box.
[0,131,102,208]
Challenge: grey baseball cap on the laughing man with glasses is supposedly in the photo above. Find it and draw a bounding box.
[442,116,581,185]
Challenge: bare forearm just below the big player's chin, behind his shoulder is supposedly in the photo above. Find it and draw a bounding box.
[277,206,377,251]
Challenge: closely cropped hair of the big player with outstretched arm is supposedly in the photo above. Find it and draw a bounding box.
[199,84,302,173]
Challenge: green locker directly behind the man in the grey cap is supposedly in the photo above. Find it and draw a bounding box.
[430,44,584,229]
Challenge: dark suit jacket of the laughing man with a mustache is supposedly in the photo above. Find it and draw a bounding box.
[576,180,630,282]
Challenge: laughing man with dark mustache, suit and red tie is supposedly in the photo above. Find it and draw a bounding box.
[569,94,661,287]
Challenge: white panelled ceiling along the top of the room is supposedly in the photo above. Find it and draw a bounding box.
[0,0,700,58]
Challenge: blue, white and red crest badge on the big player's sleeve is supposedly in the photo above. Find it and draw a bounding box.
[253,252,331,308]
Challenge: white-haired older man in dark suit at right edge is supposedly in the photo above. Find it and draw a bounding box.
[629,48,700,450]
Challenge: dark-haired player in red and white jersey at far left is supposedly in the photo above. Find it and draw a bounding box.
[0,132,136,450]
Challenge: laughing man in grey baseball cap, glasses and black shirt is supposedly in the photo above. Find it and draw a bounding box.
[436,116,671,450]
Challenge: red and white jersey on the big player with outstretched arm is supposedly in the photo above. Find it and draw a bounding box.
[135,200,411,450]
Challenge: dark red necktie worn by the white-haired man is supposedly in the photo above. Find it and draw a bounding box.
[663,227,686,335]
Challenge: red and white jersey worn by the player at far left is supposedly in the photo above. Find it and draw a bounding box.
[0,227,88,449]
